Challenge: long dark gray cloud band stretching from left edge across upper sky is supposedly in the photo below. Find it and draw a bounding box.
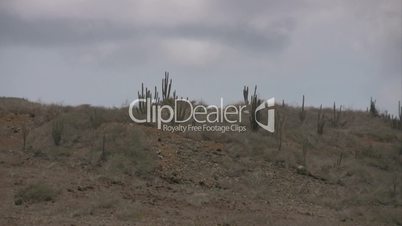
[0,5,295,56]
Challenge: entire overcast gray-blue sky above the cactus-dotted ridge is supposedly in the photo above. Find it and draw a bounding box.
[0,0,402,115]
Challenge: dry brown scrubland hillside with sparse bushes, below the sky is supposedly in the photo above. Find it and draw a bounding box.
[0,91,402,225]
